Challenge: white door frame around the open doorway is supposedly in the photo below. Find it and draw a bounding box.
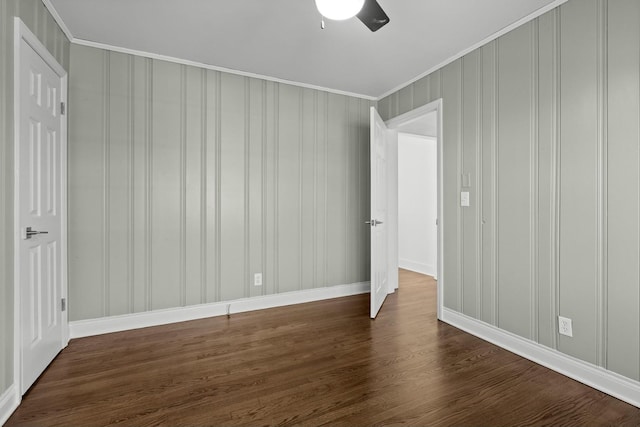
[385,98,445,319]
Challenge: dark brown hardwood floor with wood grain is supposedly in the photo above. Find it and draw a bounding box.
[7,271,640,426]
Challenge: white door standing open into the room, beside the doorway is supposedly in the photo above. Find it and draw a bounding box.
[367,107,389,319]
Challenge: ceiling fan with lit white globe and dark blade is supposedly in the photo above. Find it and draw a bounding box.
[315,0,389,31]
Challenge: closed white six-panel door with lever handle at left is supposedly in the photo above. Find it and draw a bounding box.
[16,35,63,394]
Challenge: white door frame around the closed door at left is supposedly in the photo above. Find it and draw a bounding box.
[13,17,69,402]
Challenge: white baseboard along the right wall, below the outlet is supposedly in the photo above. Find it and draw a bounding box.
[441,308,640,407]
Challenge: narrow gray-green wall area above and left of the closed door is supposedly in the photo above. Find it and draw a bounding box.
[0,0,69,395]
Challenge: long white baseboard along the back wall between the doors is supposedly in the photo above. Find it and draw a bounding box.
[69,282,371,339]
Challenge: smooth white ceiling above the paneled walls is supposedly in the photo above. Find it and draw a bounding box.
[48,0,558,98]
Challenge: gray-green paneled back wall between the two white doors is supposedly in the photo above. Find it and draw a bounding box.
[69,45,371,320]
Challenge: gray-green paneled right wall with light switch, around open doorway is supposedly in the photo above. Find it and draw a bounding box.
[379,0,640,380]
